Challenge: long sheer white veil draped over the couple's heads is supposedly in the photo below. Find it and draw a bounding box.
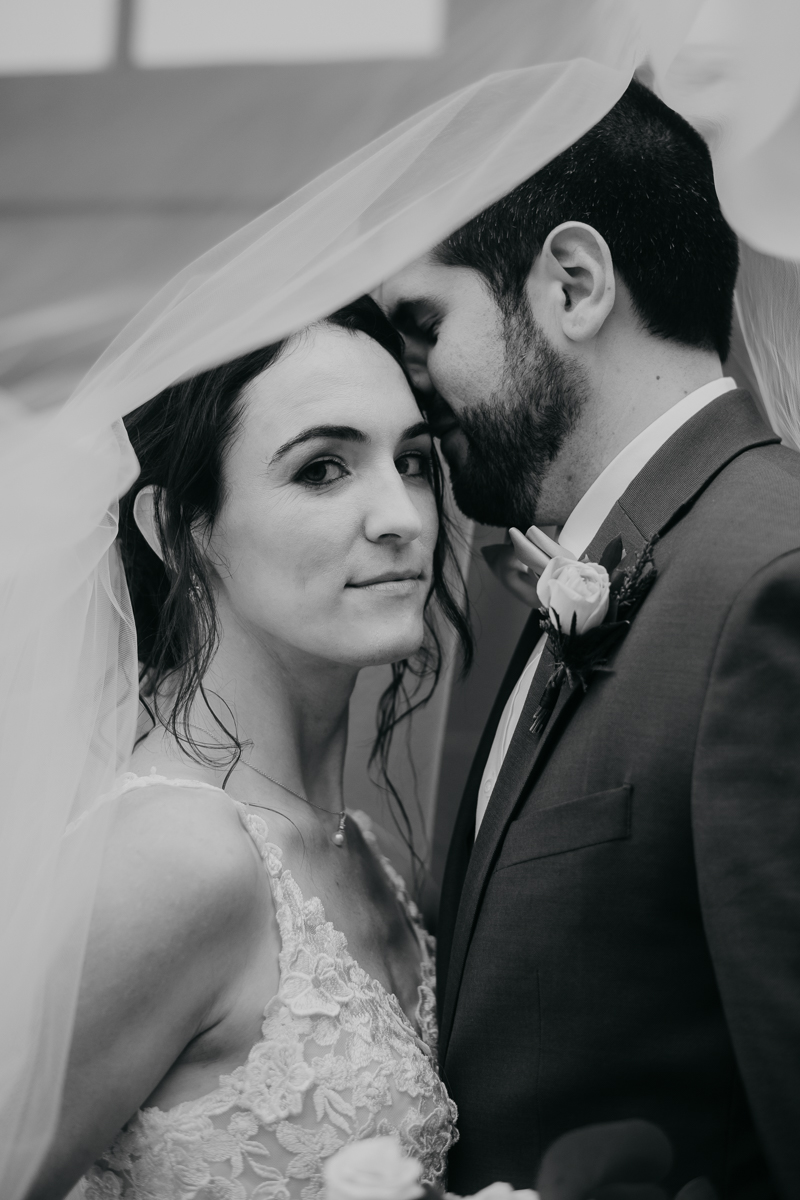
[0,0,800,1200]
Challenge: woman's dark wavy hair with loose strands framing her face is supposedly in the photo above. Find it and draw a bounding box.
[118,296,473,863]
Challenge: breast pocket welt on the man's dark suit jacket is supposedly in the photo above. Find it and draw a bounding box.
[497,784,633,871]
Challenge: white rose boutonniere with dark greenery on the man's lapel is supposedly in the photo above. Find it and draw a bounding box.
[530,538,657,733]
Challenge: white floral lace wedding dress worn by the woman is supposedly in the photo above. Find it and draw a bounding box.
[79,774,458,1200]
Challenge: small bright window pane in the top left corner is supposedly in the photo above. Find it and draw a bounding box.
[0,0,118,74]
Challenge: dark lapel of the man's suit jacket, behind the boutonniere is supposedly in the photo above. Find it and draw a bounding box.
[440,391,780,1063]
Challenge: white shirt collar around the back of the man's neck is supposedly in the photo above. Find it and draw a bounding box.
[559,376,736,556]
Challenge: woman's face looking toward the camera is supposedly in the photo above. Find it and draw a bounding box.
[207,325,438,667]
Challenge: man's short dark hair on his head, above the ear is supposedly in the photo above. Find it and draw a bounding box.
[437,80,739,359]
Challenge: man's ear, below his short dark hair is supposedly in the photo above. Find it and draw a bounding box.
[529,221,616,342]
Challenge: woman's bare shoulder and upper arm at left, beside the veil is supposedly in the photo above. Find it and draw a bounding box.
[53,780,279,1180]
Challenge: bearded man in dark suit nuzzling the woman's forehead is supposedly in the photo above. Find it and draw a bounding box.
[383,84,800,1200]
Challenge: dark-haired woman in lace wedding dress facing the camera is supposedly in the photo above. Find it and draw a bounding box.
[29,292,469,1200]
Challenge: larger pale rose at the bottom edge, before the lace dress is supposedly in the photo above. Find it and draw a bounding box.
[325,1138,423,1200]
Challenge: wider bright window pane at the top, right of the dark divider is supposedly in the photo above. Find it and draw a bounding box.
[130,0,445,67]
